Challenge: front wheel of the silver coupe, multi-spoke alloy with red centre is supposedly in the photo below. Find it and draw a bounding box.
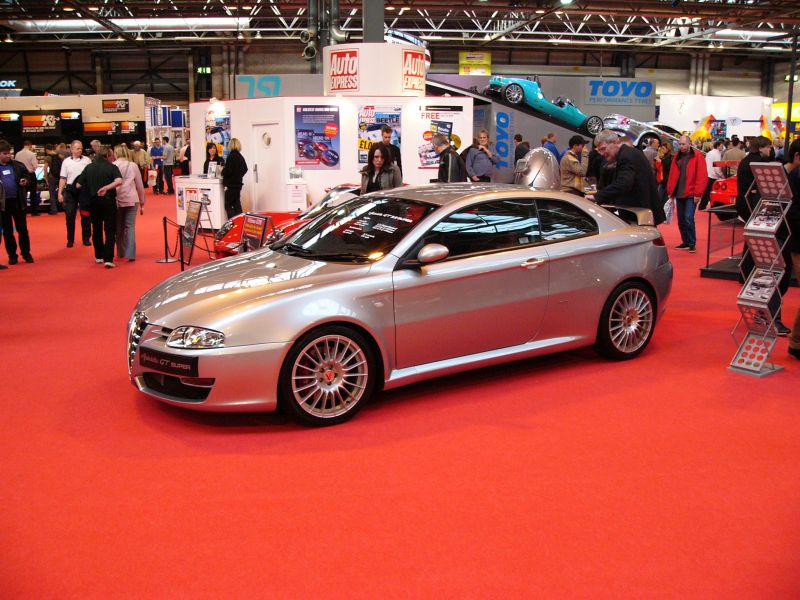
[278,325,376,426]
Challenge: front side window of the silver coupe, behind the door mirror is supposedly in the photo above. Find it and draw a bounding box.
[417,199,541,258]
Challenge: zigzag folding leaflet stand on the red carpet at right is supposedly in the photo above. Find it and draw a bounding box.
[728,163,791,377]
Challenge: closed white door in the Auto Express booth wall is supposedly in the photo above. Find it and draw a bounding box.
[249,122,287,211]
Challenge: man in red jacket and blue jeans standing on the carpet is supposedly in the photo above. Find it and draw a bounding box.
[667,135,708,252]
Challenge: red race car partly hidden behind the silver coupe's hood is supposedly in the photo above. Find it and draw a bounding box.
[214,183,361,258]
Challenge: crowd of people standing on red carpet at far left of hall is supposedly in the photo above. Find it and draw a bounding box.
[0,137,177,269]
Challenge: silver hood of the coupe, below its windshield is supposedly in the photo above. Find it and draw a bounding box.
[136,248,372,333]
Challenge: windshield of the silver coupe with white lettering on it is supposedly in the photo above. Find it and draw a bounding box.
[271,195,435,262]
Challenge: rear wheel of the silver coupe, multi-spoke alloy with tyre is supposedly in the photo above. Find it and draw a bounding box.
[596,281,656,360]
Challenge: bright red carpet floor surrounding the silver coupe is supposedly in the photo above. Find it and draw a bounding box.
[0,196,800,599]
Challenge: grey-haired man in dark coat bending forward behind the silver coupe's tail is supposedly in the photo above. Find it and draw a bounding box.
[594,129,666,225]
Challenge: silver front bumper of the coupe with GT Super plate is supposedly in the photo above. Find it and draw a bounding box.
[128,324,291,412]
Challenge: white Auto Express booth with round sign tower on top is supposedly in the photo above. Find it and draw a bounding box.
[186,44,473,217]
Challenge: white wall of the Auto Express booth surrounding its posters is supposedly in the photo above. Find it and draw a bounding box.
[189,96,473,211]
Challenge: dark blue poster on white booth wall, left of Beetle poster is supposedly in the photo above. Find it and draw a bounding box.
[294,104,341,171]
